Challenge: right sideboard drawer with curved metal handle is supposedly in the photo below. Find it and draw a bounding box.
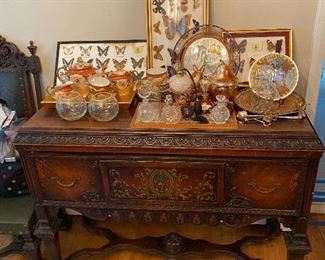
[225,159,308,210]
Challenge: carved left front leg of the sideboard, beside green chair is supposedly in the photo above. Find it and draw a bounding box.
[34,220,61,260]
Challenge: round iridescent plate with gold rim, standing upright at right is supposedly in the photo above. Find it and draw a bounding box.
[248,53,299,101]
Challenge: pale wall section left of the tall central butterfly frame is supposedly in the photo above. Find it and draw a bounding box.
[0,0,146,93]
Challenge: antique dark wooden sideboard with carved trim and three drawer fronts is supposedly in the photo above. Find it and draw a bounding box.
[15,107,324,259]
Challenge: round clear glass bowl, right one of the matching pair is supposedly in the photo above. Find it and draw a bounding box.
[88,92,119,122]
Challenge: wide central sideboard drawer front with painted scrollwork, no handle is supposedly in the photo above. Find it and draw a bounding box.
[100,157,224,210]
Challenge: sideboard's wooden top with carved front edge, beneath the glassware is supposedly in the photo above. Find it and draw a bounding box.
[15,107,324,153]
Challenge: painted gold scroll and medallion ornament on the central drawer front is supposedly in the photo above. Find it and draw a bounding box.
[109,168,217,201]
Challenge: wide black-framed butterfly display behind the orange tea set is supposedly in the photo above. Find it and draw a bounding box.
[54,40,147,85]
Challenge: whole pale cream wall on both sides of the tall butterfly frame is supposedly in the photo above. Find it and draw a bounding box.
[0,0,316,98]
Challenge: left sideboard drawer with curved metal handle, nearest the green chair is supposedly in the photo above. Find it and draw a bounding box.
[34,156,105,202]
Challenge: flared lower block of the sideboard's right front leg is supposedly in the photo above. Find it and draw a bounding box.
[283,232,311,260]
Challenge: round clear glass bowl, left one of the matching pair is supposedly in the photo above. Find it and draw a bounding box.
[55,91,87,121]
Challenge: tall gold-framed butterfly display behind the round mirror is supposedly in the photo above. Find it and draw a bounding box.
[146,0,209,68]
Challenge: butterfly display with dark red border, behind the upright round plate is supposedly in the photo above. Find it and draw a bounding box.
[225,29,293,86]
